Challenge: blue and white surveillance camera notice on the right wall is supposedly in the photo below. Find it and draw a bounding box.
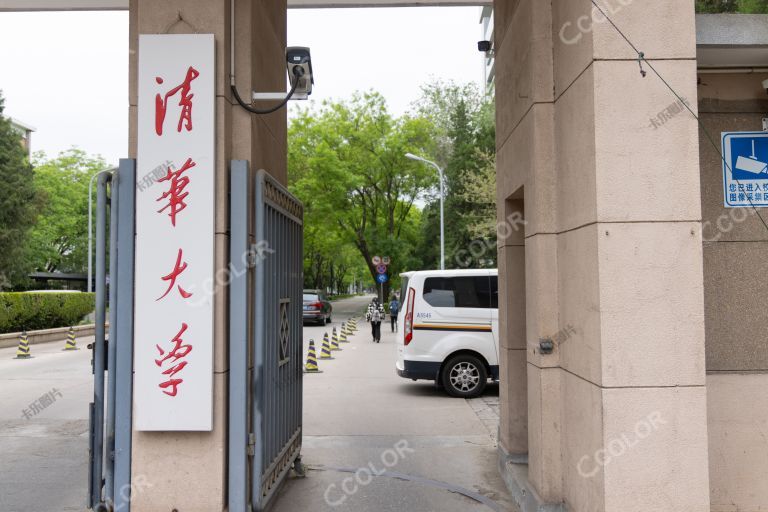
[722,132,768,208]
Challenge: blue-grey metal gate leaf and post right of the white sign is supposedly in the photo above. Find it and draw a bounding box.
[229,160,303,512]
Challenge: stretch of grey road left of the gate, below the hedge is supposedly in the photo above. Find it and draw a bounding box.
[0,330,93,512]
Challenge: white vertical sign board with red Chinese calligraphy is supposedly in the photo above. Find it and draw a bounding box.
[133,34,216,431]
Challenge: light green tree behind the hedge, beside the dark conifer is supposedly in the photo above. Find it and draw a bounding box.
[27,148,107,278]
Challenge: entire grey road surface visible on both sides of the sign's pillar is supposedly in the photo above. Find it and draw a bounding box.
[0,297,512,512]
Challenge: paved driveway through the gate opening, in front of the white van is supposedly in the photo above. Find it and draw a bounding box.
[273,299,516,512]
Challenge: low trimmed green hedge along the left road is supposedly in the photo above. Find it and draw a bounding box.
[0,293,95,333]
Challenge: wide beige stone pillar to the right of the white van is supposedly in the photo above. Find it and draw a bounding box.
[495,0,709,512]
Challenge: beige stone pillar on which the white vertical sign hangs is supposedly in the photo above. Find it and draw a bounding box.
[129,0,287,512]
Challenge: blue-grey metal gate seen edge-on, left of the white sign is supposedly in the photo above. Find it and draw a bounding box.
[87,159,136,512]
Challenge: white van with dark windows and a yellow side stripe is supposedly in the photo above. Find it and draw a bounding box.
[396,269,499,398]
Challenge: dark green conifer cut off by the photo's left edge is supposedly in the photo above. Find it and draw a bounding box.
[0,93,35,290]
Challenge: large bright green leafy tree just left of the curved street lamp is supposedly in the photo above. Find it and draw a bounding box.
[288,92,437,292]
